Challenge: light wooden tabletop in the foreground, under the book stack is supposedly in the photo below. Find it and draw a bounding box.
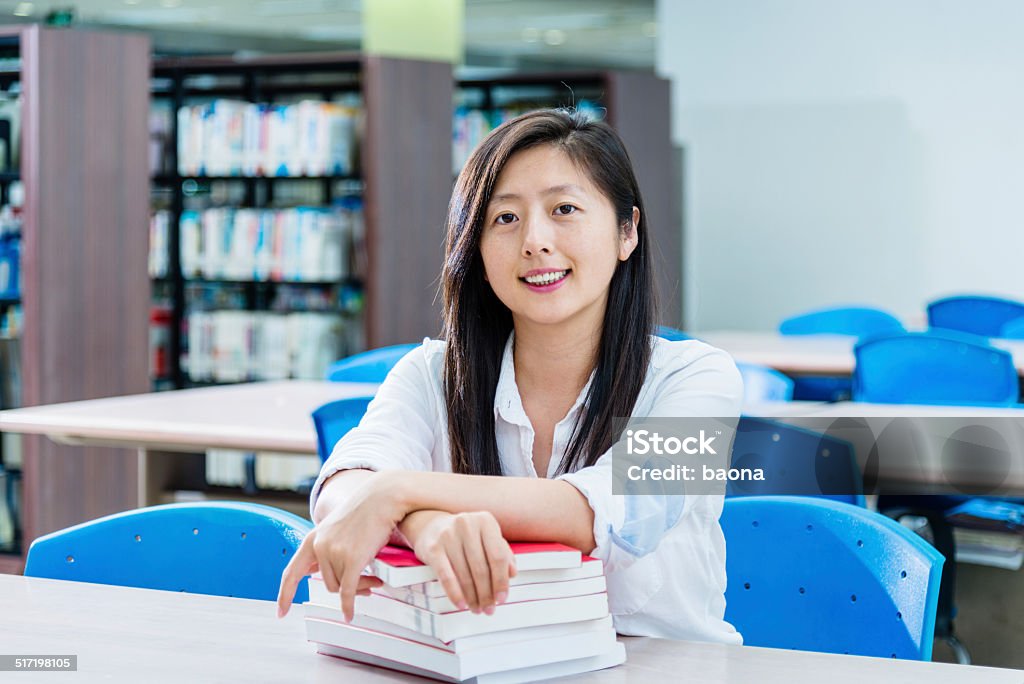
[0,575,1024,684]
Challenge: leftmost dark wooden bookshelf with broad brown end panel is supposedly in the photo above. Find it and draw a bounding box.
[0,25,150,572]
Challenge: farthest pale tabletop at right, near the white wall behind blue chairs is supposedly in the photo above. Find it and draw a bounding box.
[693,331,1024,376]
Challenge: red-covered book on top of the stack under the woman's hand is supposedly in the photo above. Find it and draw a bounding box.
[369,542,583,587]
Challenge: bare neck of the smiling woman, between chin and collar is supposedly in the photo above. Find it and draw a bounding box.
[513,325,601,396]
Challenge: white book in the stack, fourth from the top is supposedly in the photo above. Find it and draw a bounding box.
[339,593,608,641]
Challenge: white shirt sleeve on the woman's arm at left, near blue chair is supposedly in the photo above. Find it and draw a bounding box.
[309,343,438,515]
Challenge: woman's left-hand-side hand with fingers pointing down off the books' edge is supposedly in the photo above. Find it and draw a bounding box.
[278,473,406,622]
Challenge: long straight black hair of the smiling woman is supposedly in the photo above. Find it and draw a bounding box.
[441,110,654,475]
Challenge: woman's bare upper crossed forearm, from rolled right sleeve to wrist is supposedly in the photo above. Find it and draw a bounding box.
[385,471,596,553]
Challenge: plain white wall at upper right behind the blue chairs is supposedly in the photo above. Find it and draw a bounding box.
[657,0,1024,330]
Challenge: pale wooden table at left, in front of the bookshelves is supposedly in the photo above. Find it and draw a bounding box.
[0,380,378,516]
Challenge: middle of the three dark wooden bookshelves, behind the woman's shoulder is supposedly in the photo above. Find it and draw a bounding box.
[152,52,454,387]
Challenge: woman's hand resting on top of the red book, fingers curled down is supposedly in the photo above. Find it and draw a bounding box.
[402,511,516,615]
